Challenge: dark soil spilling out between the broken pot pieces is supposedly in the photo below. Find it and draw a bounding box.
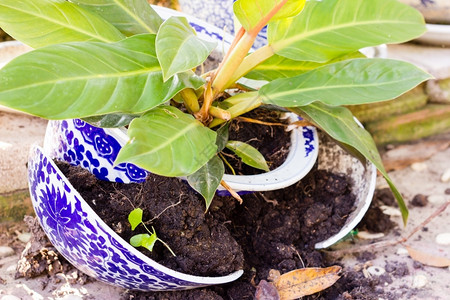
[55,157,376,299]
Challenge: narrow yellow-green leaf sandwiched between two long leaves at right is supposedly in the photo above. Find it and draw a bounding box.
[245,52,365,81]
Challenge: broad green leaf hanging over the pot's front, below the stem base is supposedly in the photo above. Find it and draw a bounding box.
[115,106,217,177]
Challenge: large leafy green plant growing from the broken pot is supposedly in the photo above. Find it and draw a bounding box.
[0,0,430,222]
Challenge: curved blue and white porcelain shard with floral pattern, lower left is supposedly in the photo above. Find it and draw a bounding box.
[28,146,243,291]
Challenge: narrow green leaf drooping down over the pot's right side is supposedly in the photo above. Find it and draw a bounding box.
[291,102,408,224]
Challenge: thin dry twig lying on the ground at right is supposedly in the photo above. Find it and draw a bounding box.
[324,201,450,258]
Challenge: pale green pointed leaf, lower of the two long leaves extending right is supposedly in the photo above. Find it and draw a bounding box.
[259,59,431,107]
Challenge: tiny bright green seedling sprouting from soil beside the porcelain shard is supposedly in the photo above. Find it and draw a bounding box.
[128,208,176,256]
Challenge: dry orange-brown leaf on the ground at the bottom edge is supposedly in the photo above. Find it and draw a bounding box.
[274,266,342,300]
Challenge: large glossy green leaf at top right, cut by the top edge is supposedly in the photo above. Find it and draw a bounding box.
[268,0,426,62]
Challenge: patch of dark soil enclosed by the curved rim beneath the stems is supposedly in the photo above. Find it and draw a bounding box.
[223,109,291,175]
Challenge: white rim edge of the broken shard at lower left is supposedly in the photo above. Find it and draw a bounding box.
[30,145,244,285]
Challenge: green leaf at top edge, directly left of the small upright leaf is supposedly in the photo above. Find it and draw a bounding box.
[70,0,163,36]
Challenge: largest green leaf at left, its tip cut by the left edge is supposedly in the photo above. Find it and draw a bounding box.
[0,34,204,119]
